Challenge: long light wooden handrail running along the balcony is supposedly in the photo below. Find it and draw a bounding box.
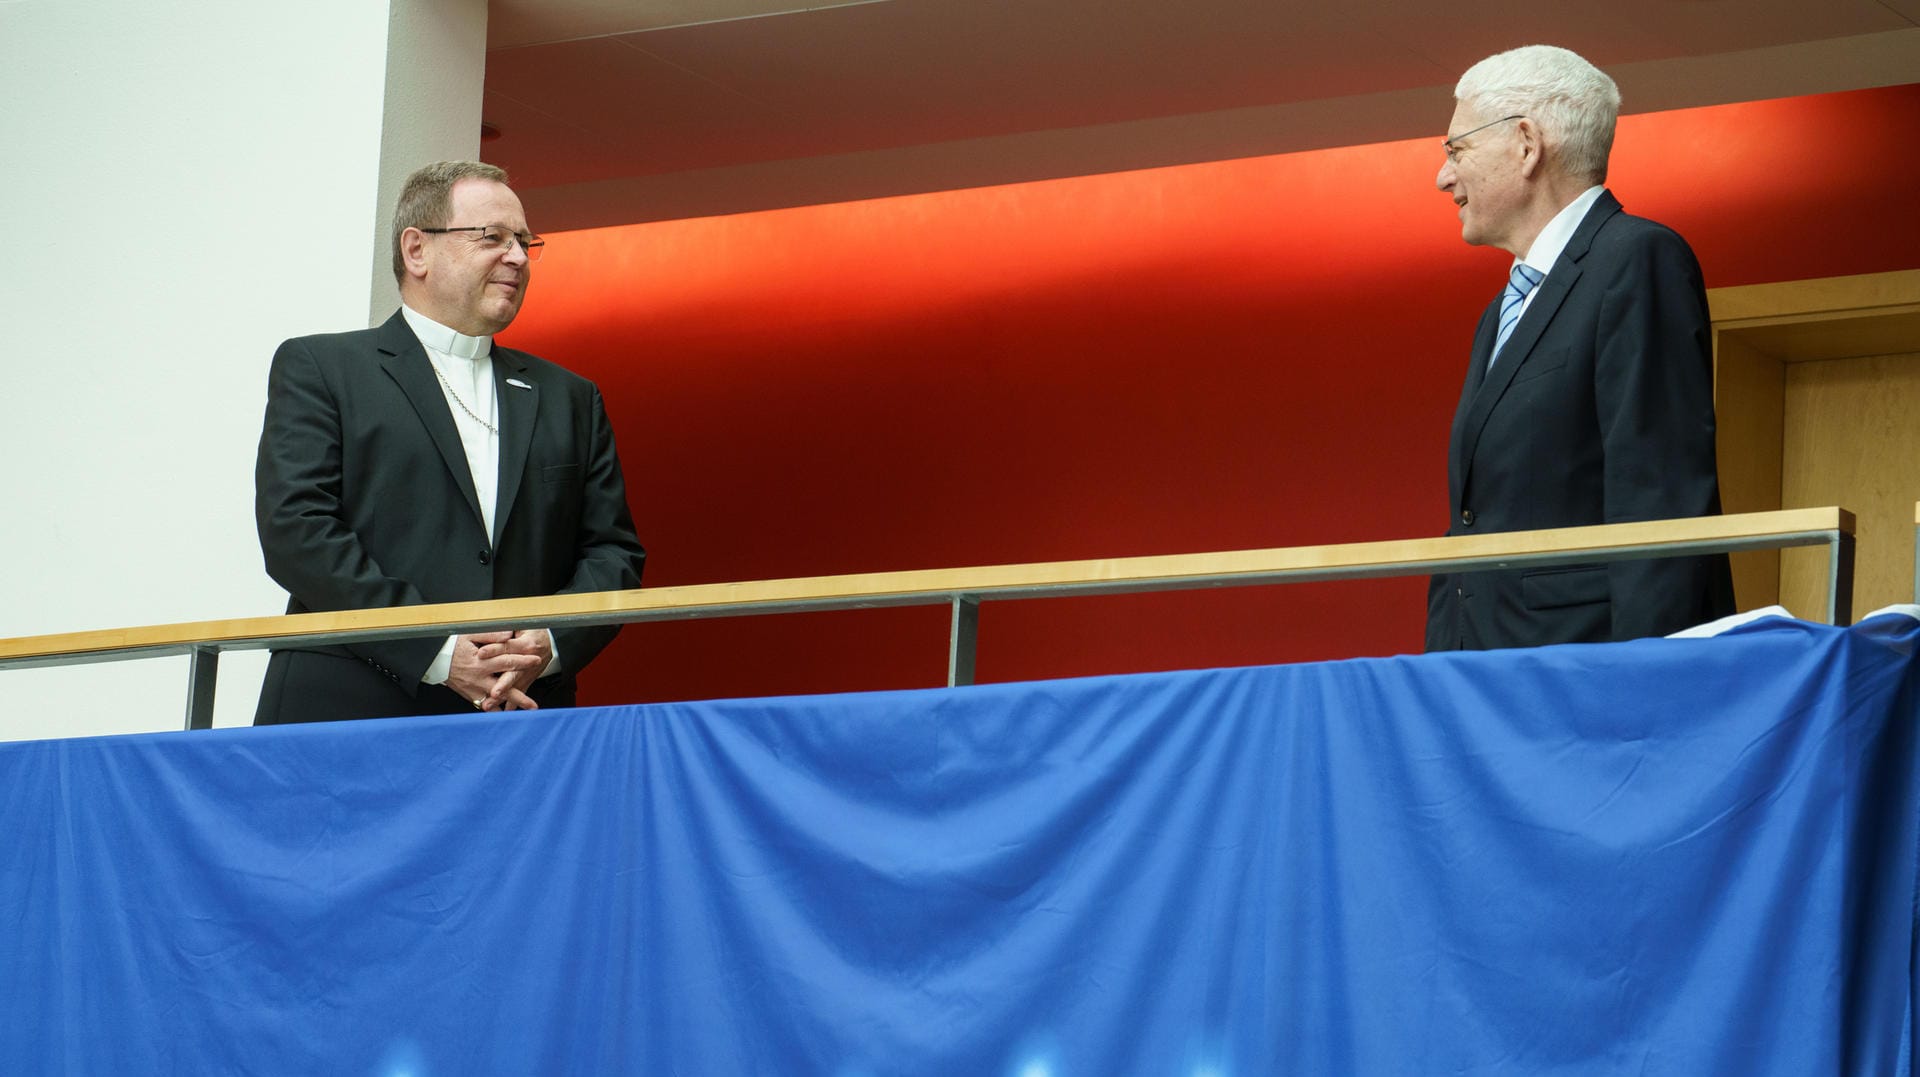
[0,505,1858,668]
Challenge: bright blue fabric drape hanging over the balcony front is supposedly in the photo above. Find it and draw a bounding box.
[0,616,1920,1077]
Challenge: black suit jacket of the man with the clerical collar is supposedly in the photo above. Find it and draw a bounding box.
[253,311,645,724]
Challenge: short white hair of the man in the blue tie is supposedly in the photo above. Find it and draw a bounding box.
[1453,44,1620,182]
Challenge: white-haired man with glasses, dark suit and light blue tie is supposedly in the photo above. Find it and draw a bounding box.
[1427,46,1734,651]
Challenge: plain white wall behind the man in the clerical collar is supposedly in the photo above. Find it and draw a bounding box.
[0,0,486,739]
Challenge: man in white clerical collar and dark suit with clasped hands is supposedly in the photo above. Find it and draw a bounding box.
[253,161,645,726]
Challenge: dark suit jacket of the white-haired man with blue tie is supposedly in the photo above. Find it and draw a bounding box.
[1427,192,1734,651]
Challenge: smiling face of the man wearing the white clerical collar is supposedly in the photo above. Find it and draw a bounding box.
[401,177,532,336]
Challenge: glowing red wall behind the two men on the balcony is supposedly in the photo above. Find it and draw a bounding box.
[505,84,1920,703]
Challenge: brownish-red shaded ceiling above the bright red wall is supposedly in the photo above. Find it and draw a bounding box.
[480,0,1920,230]
